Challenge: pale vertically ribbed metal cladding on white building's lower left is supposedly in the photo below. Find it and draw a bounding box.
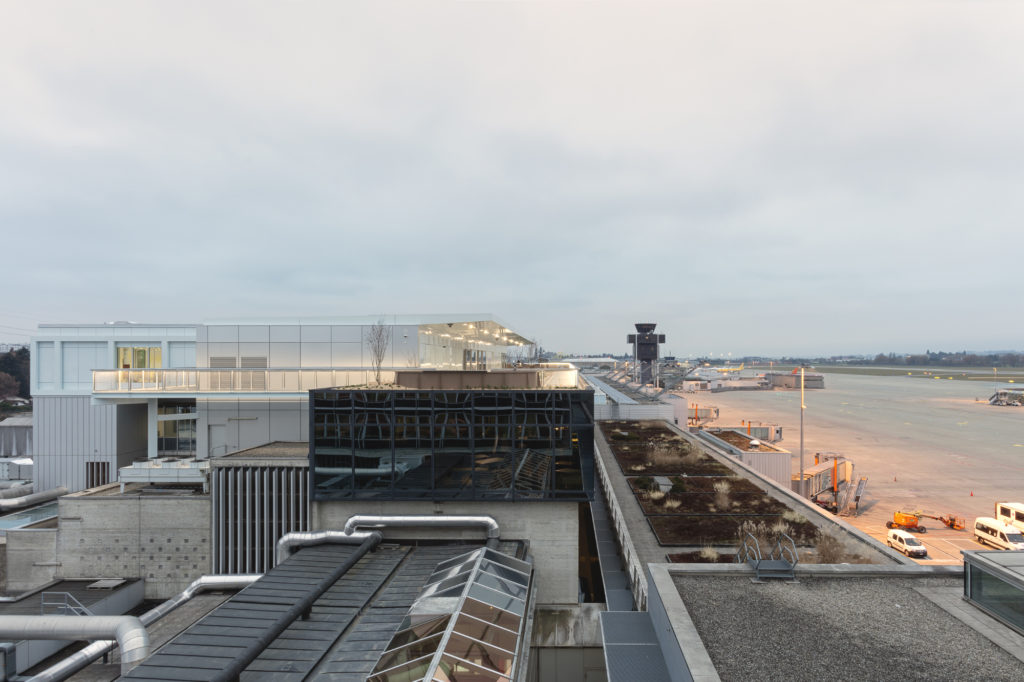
[33,395,117,492]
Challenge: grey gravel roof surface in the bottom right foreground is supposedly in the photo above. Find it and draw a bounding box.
[674,576,1024,682]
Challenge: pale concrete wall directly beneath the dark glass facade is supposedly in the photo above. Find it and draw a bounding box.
[310,500,580,604]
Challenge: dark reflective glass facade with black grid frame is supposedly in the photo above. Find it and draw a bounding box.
[309,389,594,501]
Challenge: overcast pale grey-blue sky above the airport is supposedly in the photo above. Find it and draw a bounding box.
[0,0,1024,356]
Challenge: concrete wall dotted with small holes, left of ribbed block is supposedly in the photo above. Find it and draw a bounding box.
[57,486,211,599]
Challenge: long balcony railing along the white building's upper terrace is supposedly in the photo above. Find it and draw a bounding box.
[92,368,394,393]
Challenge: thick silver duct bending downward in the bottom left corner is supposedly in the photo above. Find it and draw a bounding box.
[0,615,150,675]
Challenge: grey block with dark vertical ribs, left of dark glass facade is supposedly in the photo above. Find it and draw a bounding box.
[211,467,309,573]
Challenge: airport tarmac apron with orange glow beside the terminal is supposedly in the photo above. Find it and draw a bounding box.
[680,375,1024,563]
